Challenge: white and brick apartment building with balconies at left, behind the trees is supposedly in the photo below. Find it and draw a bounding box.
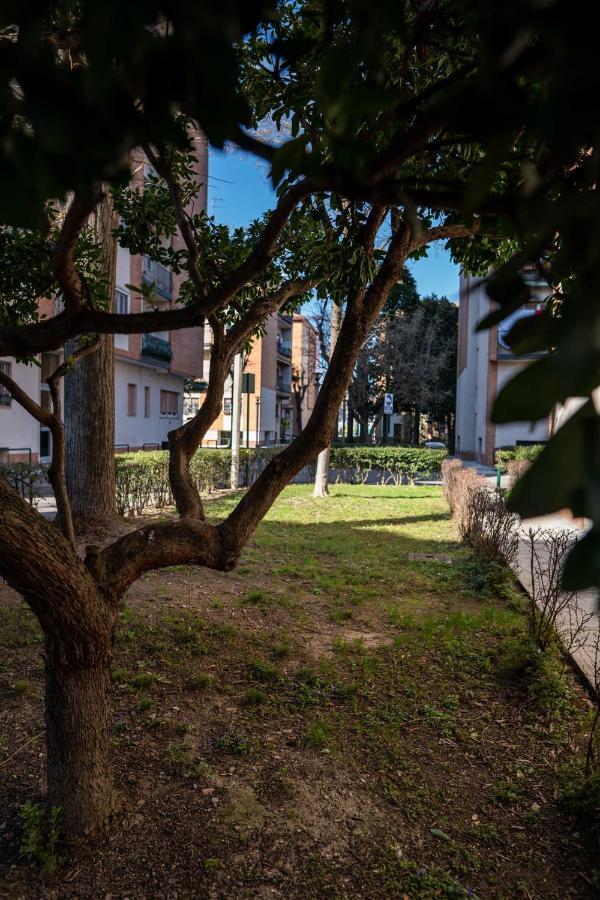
[0,145,208,462]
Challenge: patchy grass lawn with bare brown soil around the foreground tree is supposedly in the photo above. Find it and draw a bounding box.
[0,485,600,898]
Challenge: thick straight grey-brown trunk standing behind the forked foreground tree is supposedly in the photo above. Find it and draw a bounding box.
[64,192,117,530]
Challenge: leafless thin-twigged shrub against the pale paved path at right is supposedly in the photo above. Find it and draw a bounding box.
[526,528,587,652]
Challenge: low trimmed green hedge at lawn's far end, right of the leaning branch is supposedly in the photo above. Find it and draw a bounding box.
[330,446,447,485]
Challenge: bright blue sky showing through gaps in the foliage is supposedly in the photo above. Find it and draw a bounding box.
[208,149,458,300]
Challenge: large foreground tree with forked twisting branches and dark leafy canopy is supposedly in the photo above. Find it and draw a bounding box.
[0,0,600,832]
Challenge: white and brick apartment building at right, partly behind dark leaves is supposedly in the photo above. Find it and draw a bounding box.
[456,271,551,465]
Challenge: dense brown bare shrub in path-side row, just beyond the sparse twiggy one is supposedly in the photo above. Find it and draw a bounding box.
[459,485,519,566]
